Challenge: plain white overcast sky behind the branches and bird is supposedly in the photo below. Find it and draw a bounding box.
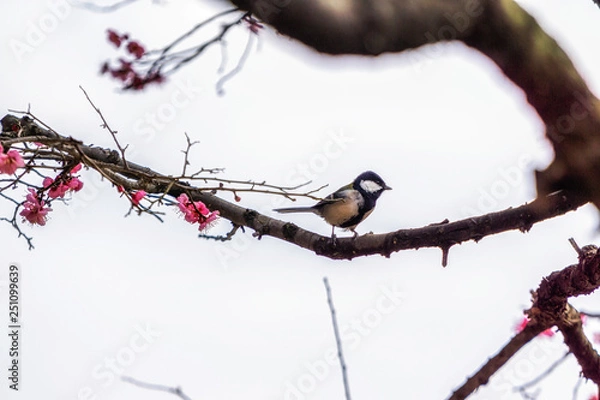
[0,0,600,400]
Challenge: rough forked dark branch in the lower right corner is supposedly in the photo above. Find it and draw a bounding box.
[449,239,600,400]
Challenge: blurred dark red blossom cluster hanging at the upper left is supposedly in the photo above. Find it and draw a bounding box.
[100,29,165,90]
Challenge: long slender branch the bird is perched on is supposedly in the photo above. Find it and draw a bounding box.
[0,115,585,260]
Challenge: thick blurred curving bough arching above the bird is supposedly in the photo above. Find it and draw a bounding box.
[228,0,600,212]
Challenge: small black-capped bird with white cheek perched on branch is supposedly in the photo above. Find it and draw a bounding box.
[273,171,392,239]
